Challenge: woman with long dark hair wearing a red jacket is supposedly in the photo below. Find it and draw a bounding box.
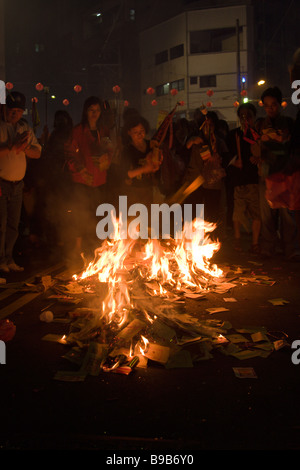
[69,96,113,253]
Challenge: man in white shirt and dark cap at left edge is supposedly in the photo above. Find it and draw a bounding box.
[0,91,41,272]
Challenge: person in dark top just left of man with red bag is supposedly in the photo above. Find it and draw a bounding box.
[228,103,261,254]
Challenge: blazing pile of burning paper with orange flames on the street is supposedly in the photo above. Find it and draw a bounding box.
[44,218,278,377]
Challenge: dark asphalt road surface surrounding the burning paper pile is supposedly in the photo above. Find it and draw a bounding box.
[0,234,300,453]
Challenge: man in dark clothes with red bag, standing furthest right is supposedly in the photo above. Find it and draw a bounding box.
[256,87,298,260]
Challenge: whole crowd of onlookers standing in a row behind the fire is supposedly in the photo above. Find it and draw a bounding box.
[0,47,300,272]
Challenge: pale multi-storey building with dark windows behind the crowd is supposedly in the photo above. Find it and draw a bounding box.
[140,5,253,128]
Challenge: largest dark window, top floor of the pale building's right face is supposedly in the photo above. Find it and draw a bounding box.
[190,27,243,54]
